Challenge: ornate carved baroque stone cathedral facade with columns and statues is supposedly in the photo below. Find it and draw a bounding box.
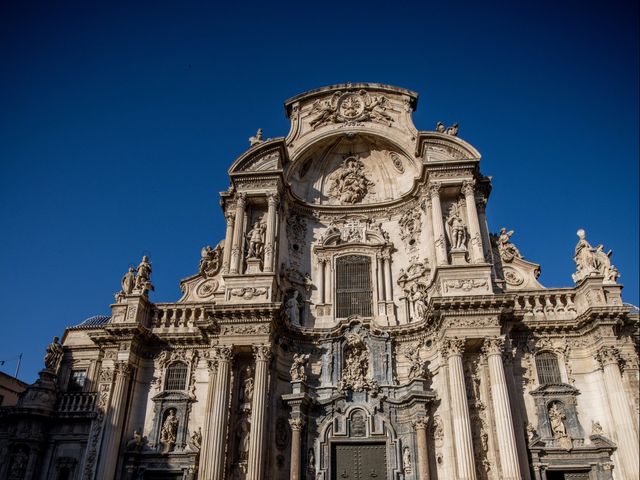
[0,84,639,480]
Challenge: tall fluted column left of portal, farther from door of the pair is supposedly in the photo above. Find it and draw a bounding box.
[208,345,233,480]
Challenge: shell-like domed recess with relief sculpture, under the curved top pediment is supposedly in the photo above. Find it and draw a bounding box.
[287,133,420,206]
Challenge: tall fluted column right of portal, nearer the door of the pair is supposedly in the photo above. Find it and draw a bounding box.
[442,338,476,480]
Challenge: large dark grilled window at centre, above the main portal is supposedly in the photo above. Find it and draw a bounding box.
[336,255,373,318]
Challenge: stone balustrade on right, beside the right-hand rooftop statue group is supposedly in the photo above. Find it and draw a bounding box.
[515,290,576,320]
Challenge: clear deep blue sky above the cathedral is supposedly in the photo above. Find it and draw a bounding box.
[0,0,639,382]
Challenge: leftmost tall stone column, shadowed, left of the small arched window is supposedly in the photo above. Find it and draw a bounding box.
[96,362,131,478]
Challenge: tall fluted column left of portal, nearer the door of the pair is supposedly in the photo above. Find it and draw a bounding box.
[247,345,271,480]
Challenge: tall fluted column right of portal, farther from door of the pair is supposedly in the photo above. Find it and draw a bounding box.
[483,337,522,480]
